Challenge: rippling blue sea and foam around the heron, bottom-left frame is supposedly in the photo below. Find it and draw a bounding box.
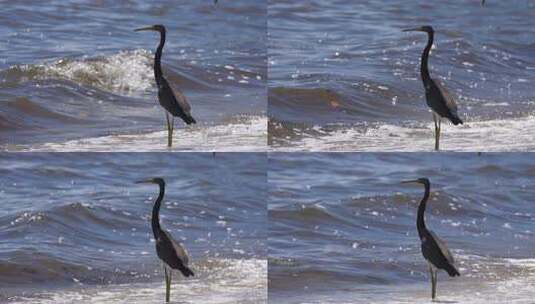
[0,153,267,304]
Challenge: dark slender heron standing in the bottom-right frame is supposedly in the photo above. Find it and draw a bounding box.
[402,178,461,300]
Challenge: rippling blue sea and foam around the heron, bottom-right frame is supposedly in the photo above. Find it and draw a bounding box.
[268,153,535,303]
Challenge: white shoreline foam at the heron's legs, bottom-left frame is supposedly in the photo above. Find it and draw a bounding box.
[13,259,267,304]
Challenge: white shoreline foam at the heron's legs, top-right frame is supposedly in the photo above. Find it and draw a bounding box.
[272,116,535,152]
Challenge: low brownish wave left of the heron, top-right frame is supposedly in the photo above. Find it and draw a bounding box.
[268,84,417,124]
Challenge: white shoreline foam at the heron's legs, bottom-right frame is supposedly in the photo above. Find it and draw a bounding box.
[270,256,535,304]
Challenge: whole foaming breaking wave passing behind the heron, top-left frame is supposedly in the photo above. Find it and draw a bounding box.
[0,49,241,97]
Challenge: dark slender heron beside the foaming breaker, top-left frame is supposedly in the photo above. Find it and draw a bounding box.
[135,24,197,147]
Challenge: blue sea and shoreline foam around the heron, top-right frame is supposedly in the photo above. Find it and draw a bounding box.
[268,0,535,152]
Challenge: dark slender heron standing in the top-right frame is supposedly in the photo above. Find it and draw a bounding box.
[403,25,463,151]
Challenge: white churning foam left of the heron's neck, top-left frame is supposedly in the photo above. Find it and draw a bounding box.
[39,50,154,95]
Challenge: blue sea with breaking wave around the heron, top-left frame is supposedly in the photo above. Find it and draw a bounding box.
[0,0,267,151]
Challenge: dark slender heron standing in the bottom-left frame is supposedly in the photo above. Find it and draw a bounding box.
[136,177,194,302]
